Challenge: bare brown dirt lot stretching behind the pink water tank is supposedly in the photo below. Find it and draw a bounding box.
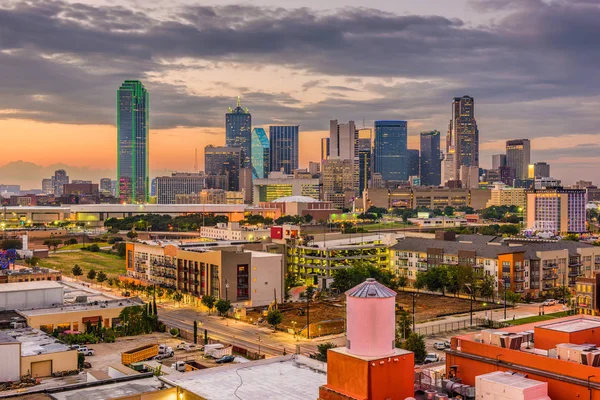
[247,292,490,329]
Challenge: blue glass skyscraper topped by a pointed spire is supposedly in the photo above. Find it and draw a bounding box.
[225,96,252,168]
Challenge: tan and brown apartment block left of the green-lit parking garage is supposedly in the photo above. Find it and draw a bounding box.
[125,243,283,307]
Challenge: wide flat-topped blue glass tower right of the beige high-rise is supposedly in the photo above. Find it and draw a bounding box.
[373,121,408,181]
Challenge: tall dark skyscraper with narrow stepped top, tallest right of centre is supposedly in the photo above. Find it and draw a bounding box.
[446,96,479,180]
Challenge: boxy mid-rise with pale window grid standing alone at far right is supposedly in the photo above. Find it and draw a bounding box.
[527,187,586,235]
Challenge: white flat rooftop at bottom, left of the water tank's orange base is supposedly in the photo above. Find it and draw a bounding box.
[161,355,327,400]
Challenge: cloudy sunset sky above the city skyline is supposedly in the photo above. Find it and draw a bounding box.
[0,0,600,188]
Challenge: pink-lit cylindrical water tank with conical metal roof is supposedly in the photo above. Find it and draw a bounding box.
[346,278,396,357]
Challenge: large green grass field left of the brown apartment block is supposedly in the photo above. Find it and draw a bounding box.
[39,251,125,277]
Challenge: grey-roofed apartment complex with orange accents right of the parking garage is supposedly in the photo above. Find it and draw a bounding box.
[390,232,600,297]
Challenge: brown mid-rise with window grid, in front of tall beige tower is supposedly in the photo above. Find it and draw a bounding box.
[321,158,356,209]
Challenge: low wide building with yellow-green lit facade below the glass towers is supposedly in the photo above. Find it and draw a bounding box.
[252,171,321,204]
